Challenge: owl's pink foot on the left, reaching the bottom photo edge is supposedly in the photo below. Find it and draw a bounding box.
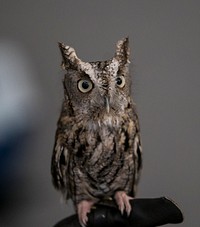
[77,200,94,227]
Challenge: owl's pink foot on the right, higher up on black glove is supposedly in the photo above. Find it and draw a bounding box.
[114,191,133,216]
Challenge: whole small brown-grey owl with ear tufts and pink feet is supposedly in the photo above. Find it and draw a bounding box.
[51,38,142,226]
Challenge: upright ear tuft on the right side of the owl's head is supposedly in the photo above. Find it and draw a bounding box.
[115,37,130,66]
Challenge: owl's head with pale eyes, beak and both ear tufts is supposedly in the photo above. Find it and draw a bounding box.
[59,38,133,118]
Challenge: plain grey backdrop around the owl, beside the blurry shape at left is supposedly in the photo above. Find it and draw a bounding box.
[0,0,200,227]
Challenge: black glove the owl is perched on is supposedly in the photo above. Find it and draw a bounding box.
[54,197,183,227]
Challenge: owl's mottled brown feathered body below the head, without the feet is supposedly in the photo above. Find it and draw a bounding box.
[52,106,142,203]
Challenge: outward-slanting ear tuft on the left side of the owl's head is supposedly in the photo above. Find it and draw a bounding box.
[58,43,81,70]
